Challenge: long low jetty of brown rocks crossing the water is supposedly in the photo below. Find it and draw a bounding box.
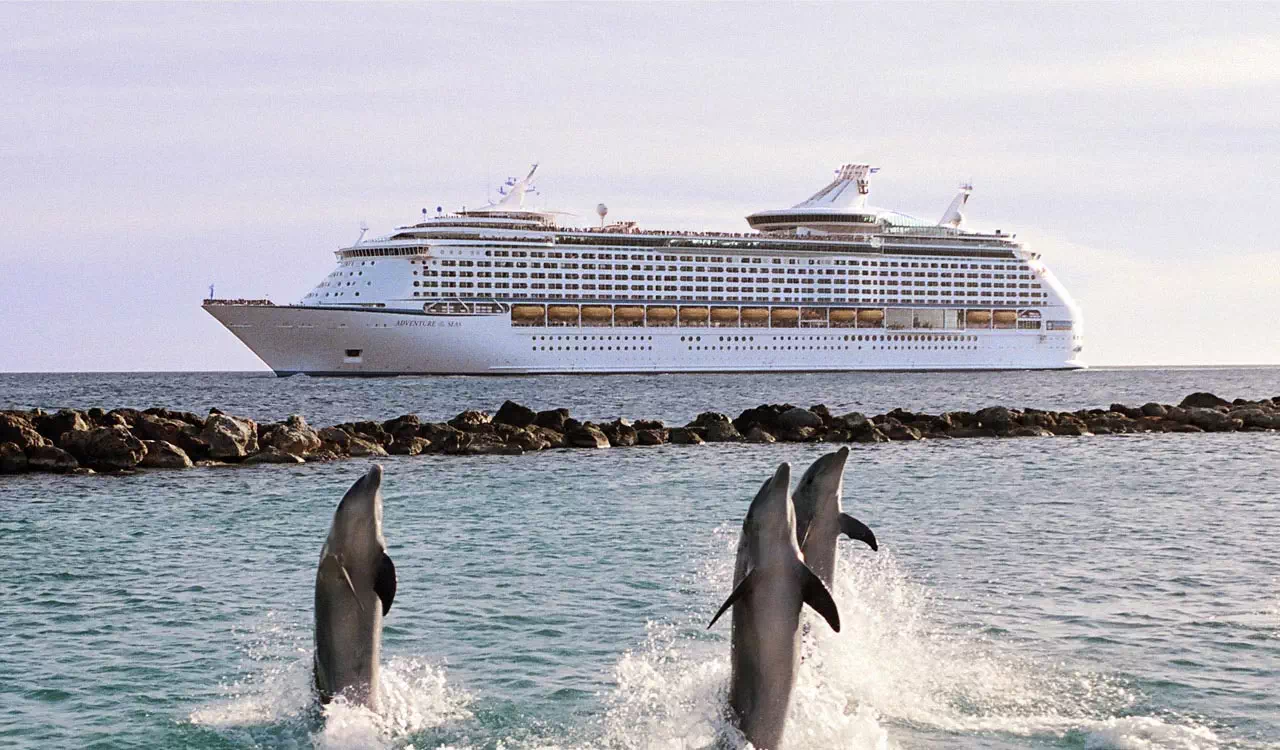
[0,393,1280,474]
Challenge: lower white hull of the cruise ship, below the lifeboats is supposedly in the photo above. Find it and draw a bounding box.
[205,305,1084,376]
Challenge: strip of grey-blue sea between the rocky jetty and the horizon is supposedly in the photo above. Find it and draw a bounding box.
[0,366,1280,425]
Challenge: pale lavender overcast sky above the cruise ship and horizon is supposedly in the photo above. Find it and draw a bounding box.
[0,3,1280,371]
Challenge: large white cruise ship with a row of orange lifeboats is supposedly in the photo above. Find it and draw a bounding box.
[204,164,1084,376]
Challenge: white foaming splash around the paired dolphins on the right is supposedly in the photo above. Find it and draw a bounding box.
[591,545,1220,750]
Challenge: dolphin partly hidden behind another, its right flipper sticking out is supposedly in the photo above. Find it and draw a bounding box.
[792,448,879,589]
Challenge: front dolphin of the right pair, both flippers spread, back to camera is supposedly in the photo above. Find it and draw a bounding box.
[707,463,840,750]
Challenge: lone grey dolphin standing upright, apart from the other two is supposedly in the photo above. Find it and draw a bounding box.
[315,466,396,710]
